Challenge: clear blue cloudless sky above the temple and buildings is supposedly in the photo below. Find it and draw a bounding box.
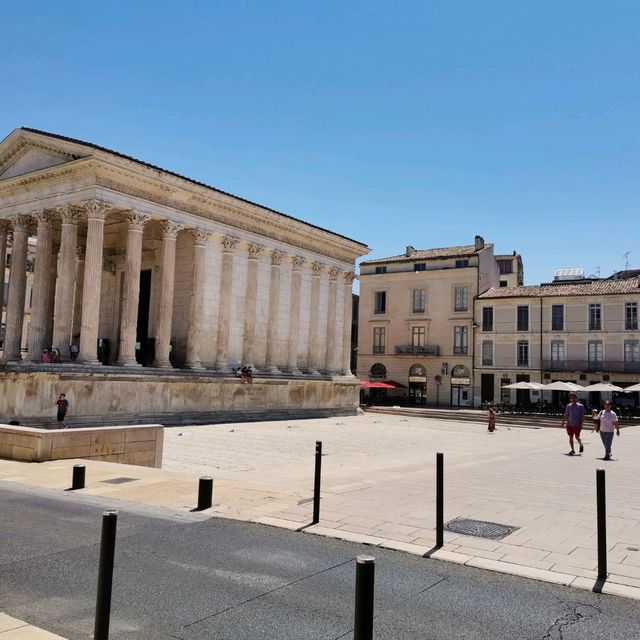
[0,0,640,284]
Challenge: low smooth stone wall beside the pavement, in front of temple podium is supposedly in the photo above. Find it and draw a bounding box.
[0,424,164,468]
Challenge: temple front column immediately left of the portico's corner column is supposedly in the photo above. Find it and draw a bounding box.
[52,206,82,360]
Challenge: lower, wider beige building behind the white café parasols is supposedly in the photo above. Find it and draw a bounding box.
[474,277,640,405]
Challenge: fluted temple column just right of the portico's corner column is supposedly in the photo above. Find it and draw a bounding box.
[116,211,149,367]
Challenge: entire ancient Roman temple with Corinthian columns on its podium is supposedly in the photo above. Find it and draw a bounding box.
[0,129,368,420]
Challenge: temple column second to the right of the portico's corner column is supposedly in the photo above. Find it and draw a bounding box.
[155,220,184,369]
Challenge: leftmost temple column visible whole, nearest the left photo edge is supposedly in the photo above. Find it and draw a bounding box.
[2,216,31,362]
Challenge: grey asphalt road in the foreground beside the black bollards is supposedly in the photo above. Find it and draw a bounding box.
[0,482,640,640]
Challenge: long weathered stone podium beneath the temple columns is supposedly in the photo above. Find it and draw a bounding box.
[0,367,359,426]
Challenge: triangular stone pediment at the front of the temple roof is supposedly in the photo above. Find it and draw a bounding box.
[0,130,90,180]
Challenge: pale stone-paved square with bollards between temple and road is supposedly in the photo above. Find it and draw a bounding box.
[0,414,640,599]
